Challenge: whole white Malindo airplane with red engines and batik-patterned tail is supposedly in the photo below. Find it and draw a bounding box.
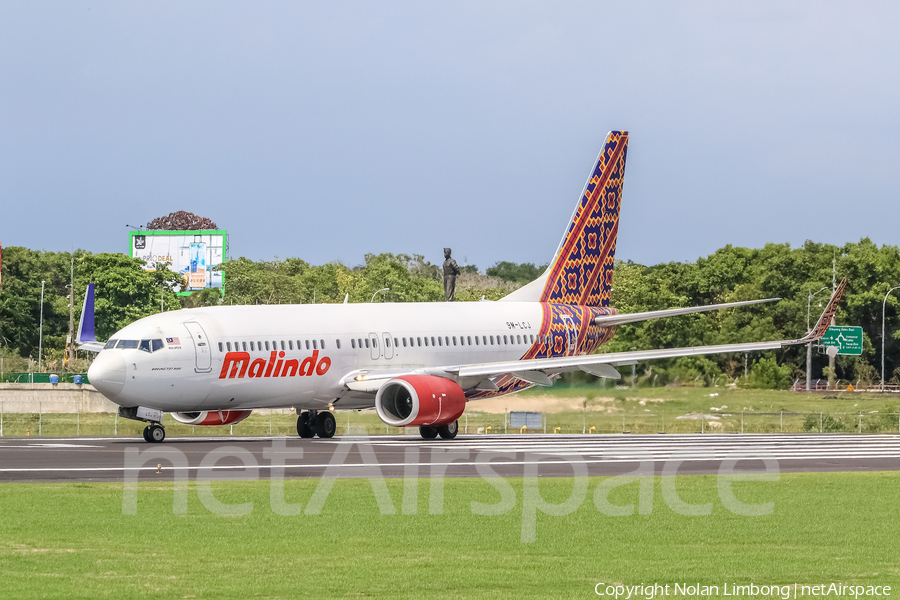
[78,131,846,442]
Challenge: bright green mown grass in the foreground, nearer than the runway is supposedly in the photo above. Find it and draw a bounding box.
[0,473,900,598]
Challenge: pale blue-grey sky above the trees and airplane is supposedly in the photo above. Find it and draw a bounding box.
[0,0,900,270]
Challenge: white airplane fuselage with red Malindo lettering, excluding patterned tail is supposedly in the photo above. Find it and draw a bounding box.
[89,302,564,412]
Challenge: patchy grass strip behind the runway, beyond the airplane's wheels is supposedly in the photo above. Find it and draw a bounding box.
[2,386,900,437]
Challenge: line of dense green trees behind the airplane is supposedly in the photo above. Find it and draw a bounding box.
[0,238,900,387]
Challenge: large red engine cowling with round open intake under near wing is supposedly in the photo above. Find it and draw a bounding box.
[375,375,466,427]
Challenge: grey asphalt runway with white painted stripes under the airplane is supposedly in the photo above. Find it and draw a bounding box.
[0,434,900,482]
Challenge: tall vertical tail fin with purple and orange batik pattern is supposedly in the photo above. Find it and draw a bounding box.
[541,131,628,307]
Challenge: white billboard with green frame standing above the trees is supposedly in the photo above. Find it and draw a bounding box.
[128,230,227,295]
